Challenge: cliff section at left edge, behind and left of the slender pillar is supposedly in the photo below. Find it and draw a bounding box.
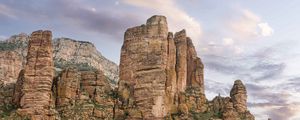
[0,34,29,84]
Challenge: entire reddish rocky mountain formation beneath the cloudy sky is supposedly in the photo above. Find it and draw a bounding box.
[0,15,255,120]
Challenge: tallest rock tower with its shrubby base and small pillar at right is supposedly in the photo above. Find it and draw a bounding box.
[116,16,254,120]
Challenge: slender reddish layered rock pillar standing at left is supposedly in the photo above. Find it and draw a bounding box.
[18,30,54,120]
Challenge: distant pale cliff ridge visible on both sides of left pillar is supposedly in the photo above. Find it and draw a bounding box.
[0,33,119,87]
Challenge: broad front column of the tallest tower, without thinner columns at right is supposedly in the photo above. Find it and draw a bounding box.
[119,16,172,119]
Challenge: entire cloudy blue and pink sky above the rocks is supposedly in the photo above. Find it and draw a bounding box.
[0,0,300,120]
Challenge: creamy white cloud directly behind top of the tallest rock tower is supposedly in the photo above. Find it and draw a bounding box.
[124,0,202,47]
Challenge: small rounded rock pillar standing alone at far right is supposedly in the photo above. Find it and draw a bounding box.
[230,80,247,113]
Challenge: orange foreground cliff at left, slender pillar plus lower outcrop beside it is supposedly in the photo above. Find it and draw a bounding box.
[0,30,115,120]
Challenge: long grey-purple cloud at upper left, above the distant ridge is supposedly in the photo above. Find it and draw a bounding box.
[0,0,142,42]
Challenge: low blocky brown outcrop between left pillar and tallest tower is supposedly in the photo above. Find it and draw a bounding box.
[53,68,114,120]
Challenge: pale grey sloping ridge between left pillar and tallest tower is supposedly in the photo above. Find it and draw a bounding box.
[53,38,119,87]
